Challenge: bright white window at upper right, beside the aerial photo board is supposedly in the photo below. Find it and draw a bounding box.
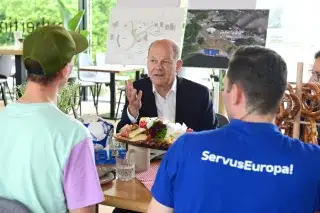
[257,0,320,82]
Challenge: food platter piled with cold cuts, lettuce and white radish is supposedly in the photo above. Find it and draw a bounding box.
[114,117,192,150]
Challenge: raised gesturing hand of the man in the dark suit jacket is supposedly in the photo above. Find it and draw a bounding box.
[126,81,142,118]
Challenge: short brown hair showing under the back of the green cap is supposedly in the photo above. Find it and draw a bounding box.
[24,59,60,86]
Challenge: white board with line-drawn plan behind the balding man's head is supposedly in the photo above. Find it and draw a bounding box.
[107,8,185,65]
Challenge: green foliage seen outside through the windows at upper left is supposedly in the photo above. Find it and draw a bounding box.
[0,0,116,58]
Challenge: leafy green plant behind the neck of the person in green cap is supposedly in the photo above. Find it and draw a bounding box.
[15,82,80,114]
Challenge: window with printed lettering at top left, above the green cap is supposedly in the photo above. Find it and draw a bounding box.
[0,0,78,45]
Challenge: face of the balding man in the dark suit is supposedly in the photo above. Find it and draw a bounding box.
[147,43,182,87]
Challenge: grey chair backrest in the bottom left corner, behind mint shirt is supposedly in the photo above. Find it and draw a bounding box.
[0,197,32,213]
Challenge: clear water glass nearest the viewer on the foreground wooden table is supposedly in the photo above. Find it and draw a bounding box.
[116,150,135,181]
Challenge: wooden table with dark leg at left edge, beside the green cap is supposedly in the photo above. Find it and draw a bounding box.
[0,46,27,85]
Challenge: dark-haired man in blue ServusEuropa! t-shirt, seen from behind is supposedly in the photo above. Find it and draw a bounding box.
[148,46,320,213]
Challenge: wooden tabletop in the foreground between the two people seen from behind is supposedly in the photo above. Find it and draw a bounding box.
[100,161,160,212]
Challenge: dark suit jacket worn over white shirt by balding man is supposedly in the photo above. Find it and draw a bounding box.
[117,77,218,132]
